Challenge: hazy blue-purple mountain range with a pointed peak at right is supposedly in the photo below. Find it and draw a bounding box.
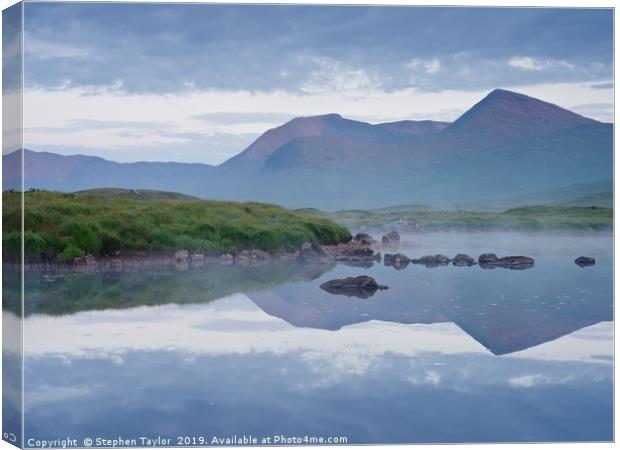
[3,89,613,210]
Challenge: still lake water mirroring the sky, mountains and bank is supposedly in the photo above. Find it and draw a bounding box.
[4,233,613,445]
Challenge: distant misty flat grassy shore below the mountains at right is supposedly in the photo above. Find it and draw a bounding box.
[304,206,613,231]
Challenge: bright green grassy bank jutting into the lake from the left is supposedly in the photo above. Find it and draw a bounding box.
[2,191,350,261]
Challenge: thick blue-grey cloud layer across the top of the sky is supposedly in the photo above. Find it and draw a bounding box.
[25,3,613,93]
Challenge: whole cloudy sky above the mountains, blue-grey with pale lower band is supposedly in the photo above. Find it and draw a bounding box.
[3,3,613,164]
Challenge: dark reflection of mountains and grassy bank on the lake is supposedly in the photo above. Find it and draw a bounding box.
[3,244,612,355]
